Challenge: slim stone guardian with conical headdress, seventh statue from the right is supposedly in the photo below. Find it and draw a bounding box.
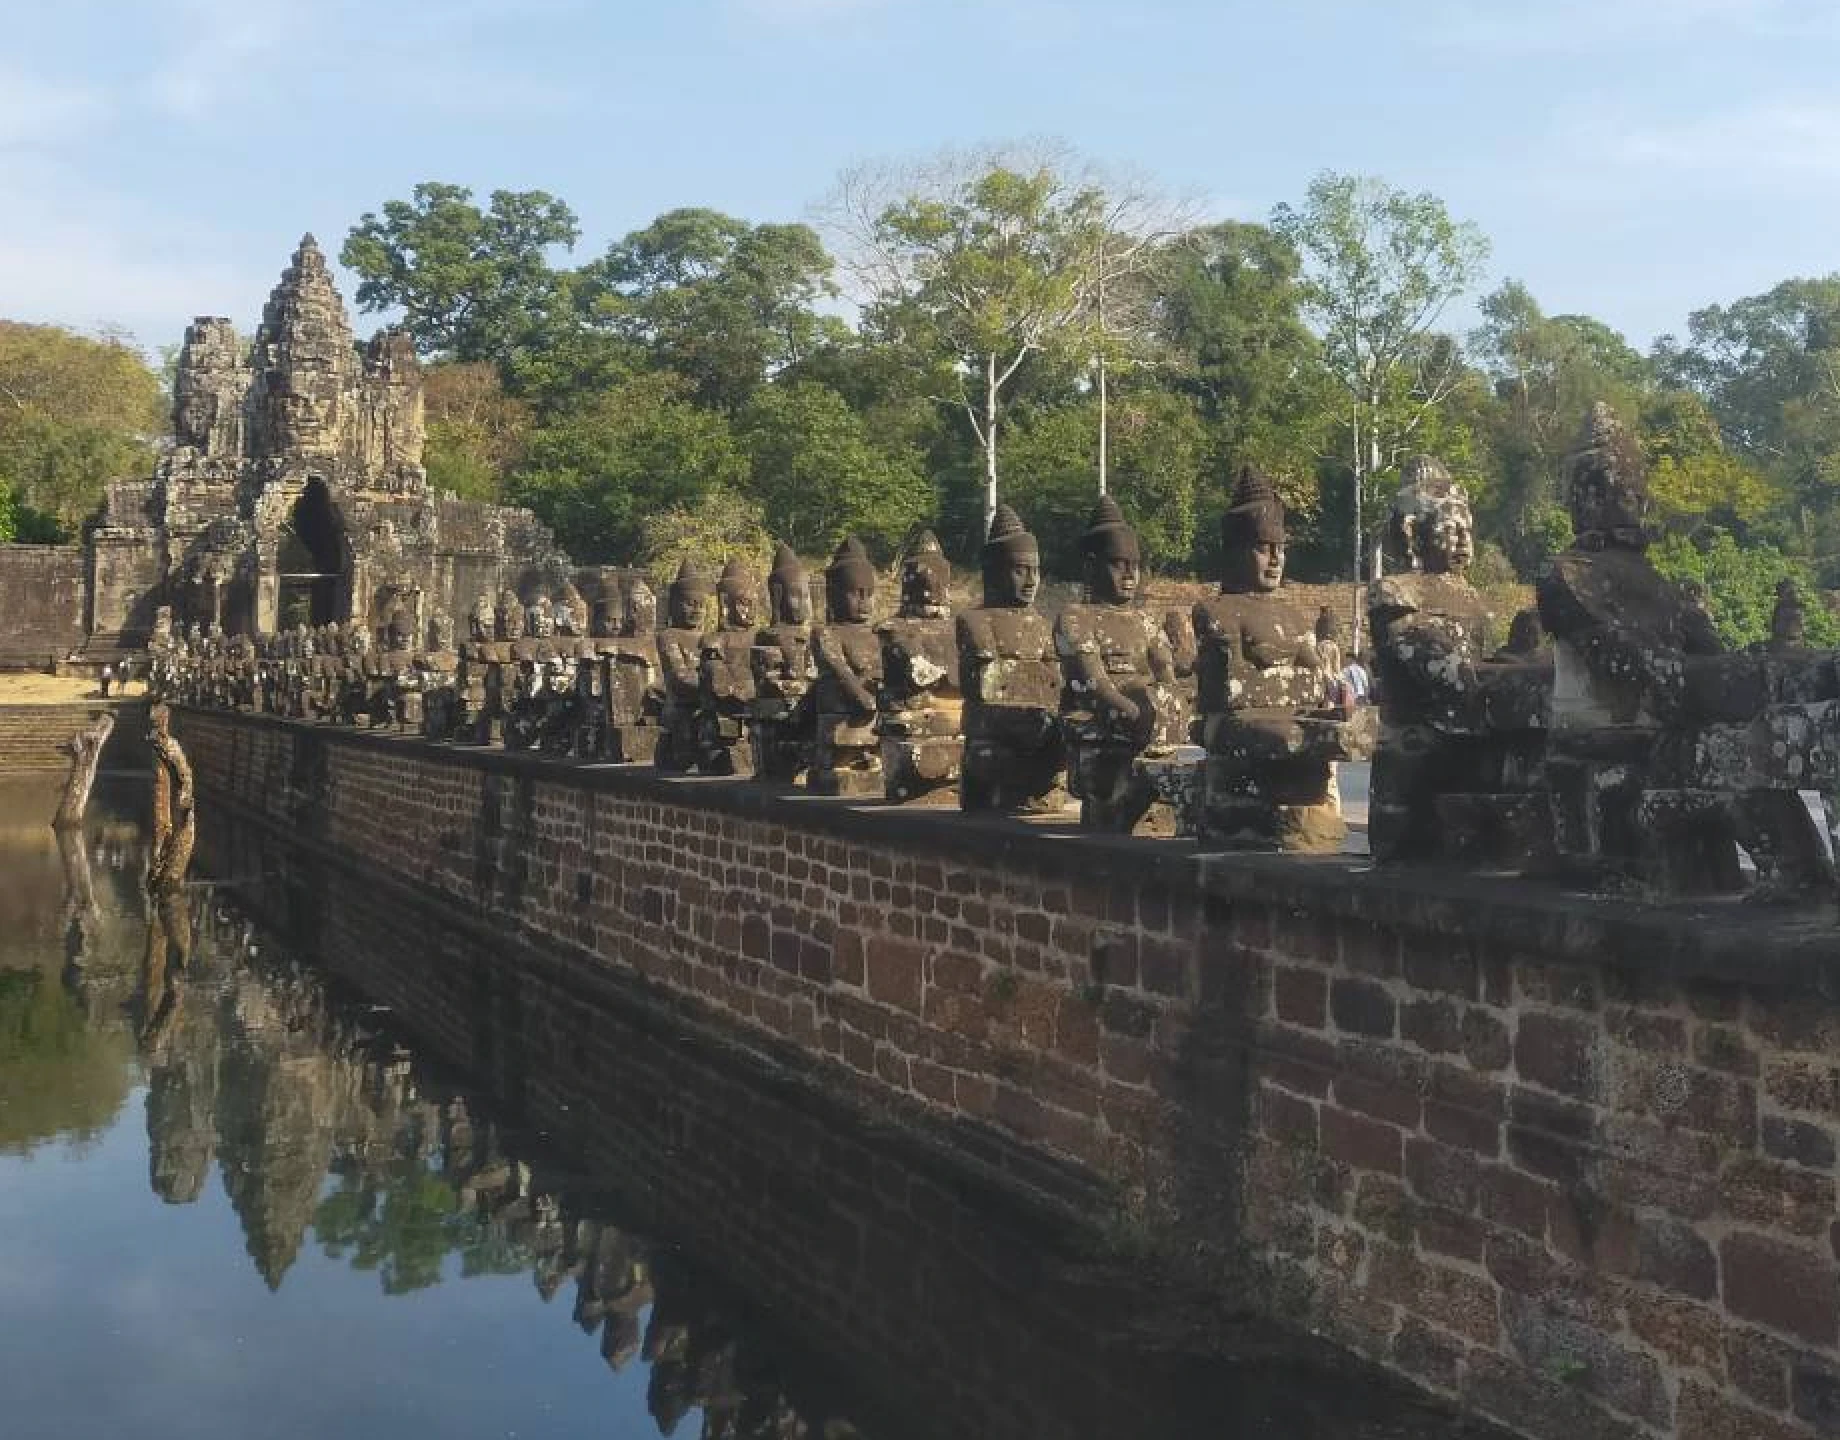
[806,535,881,794]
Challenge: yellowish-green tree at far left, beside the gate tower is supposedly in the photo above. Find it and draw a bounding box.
[0,320,164,541]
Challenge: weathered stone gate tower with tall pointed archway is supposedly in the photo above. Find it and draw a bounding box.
[90,235,567,649]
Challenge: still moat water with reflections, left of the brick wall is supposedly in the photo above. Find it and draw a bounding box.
[0,778,1474,1440]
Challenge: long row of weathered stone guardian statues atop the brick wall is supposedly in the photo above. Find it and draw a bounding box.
[154,406,1840,894]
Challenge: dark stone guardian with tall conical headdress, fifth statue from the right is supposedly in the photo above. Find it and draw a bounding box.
[955,506,1069,815]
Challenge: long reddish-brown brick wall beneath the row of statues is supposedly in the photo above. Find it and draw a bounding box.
[180,714,1840,1440]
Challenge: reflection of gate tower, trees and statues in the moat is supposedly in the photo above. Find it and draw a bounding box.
[123,892,856,1440]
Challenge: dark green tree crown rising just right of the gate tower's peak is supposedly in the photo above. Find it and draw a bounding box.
[339,180,581,364]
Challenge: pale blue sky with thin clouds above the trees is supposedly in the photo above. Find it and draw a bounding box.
[0,0,1840,348]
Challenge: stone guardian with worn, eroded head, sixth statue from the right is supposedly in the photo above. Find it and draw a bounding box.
[876,530,964,804]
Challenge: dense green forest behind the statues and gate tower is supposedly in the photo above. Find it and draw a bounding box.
[0,151,1840,640]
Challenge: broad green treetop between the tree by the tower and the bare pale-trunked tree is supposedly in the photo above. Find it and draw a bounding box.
[574,210,846,412]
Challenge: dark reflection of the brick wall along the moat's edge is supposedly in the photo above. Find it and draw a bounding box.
[201,815,1478,1440]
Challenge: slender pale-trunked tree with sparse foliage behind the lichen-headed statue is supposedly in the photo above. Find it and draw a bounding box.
[1271,171,1489,603]
